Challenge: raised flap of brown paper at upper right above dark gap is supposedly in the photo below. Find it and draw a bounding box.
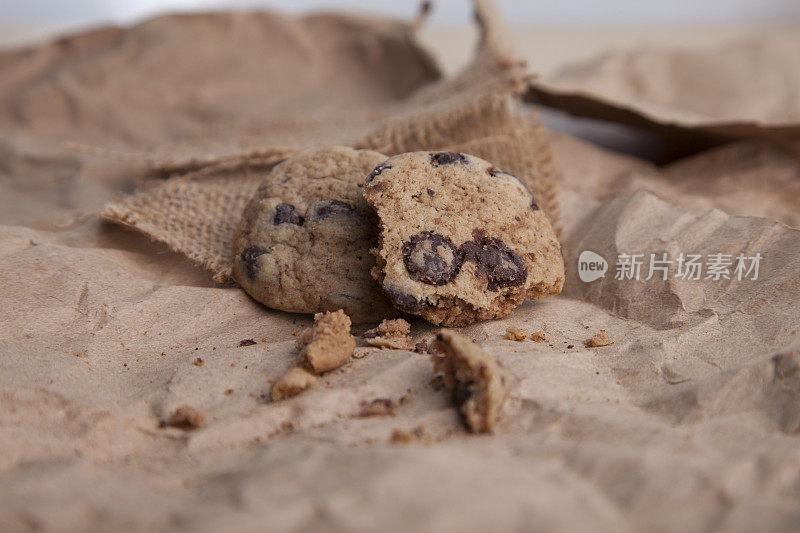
[527,31,800,149]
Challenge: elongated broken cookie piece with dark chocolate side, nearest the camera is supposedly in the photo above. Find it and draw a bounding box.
[432,330,506,433]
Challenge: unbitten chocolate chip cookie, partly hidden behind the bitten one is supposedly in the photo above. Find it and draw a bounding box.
[233,147,396,322]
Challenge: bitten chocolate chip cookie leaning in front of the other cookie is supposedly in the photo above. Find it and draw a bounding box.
[364,152,564,326]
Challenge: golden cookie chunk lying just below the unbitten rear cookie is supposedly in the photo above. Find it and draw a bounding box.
[297,309,356,374]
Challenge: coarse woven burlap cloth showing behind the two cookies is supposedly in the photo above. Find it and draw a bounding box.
[102,0,560,282]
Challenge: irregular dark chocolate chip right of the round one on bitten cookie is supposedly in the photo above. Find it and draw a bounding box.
[460,232,528,291]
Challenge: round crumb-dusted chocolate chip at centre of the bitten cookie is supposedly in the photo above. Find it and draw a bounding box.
[402,231,461,285]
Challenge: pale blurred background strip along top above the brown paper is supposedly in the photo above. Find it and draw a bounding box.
[0,0,800,49]
